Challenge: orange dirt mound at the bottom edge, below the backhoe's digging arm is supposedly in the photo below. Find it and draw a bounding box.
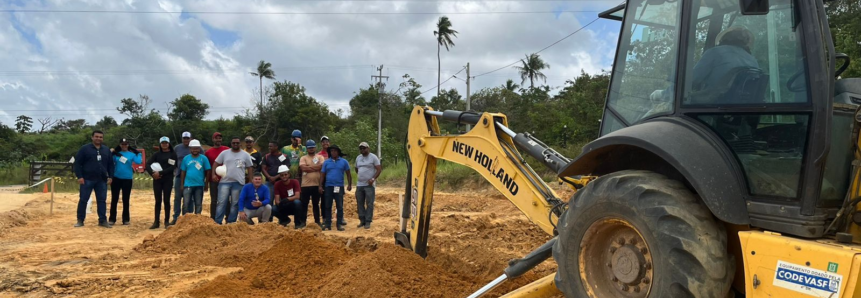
[317,244,472,297]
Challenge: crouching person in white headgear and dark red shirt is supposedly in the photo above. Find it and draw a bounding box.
[272,165,308,229]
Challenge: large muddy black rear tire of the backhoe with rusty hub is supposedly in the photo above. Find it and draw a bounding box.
[553,171,735,298]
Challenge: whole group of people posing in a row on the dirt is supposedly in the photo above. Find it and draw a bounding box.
[74,130,382,231]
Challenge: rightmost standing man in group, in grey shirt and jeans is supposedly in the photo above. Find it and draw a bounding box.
[356,142,383,229]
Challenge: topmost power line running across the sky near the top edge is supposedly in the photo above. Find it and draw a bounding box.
[0,9,601,15]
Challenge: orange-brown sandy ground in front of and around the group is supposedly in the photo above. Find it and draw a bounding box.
[0,188,568,297]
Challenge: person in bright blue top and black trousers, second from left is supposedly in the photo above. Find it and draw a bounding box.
[108,139,141,226]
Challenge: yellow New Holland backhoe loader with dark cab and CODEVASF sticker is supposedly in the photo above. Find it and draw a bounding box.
[395,0,861,298]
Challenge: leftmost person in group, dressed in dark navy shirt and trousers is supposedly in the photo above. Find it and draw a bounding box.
[73,130,114,228]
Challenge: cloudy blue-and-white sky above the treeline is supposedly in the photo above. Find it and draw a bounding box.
[0,0,621,126]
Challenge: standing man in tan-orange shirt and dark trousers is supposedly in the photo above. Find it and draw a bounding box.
[299,140,326,228]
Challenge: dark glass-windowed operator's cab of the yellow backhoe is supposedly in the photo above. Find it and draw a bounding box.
[584,0,861,238]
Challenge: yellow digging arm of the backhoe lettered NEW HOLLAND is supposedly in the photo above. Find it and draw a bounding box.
[395,106,565,257]
